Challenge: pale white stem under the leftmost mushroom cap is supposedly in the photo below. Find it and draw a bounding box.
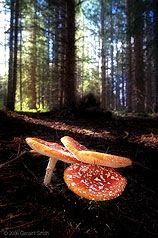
[44,158,58,185]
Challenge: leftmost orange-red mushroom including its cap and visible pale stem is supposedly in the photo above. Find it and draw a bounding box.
[26,137,78,185]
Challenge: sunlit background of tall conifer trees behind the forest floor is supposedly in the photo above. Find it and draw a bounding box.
[0,0,158,113]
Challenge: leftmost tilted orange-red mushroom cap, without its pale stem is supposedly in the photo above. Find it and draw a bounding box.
[26,137,78,163]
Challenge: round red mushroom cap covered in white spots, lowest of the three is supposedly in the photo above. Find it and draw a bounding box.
[64,163,127,201]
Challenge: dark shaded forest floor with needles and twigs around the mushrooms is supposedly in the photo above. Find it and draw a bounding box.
[0,111,158,238]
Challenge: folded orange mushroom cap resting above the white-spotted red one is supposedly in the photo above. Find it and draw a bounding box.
[61,136,132,168]
